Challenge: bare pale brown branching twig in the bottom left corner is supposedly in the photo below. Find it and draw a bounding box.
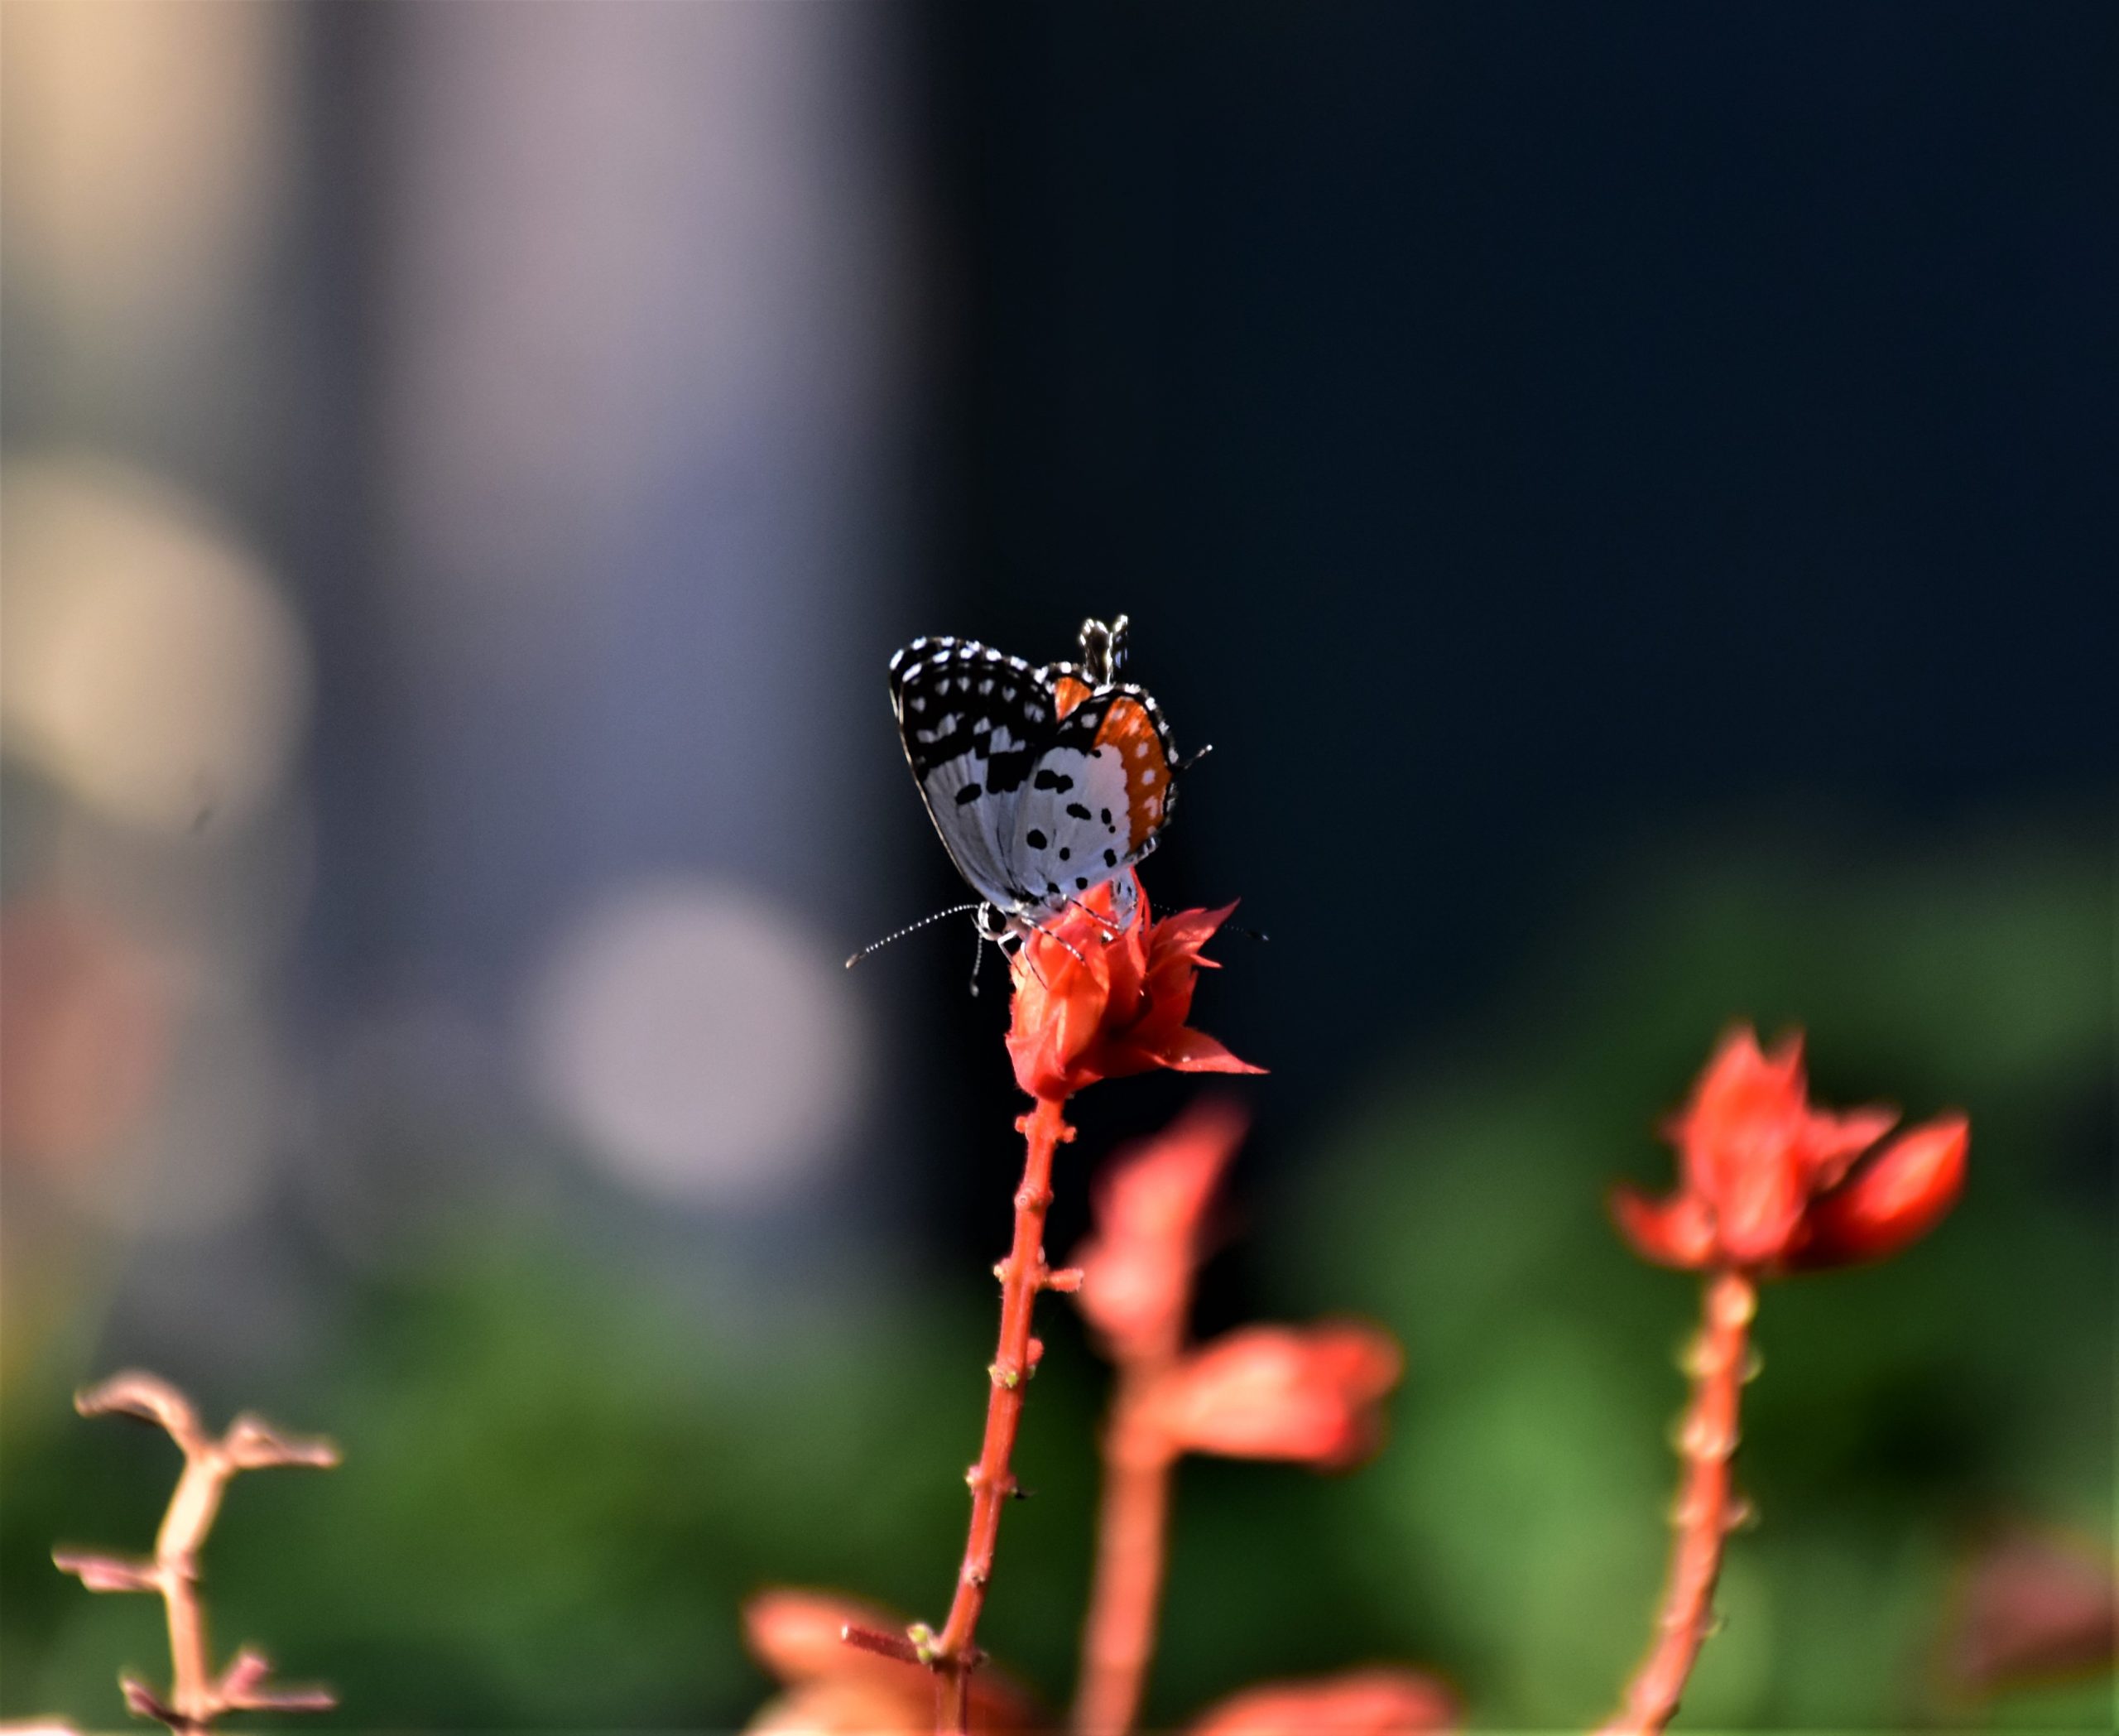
[50,1372,339,1732]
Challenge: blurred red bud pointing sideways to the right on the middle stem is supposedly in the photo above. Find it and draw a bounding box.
[1149,1325,1405,1471]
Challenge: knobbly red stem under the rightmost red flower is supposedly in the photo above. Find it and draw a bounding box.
[1598,1272,1759,1736]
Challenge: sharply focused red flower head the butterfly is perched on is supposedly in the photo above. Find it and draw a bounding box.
[1009,871,1265,1102]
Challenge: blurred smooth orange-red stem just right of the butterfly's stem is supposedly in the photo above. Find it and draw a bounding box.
[1074,1382,1178,1736]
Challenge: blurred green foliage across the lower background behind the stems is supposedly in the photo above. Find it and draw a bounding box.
[0,826,2115,1729]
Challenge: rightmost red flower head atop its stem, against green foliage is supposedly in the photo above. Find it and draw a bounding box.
[1611,1026,1971,1272]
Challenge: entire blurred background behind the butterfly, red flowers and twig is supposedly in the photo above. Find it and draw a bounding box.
[0,0,2119,1729]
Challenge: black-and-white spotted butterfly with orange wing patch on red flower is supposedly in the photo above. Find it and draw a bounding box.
[856,615,1180,956]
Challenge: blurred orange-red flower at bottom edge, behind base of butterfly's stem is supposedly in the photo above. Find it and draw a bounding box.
[744,1588,1043,1736]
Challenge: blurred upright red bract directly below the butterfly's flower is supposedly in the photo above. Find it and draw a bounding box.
[1074,1100,1250,1363]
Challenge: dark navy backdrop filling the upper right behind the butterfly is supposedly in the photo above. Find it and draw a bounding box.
[909,4,2119,1238]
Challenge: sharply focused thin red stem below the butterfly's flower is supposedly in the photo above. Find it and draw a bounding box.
[924,1098,1074,1732]
